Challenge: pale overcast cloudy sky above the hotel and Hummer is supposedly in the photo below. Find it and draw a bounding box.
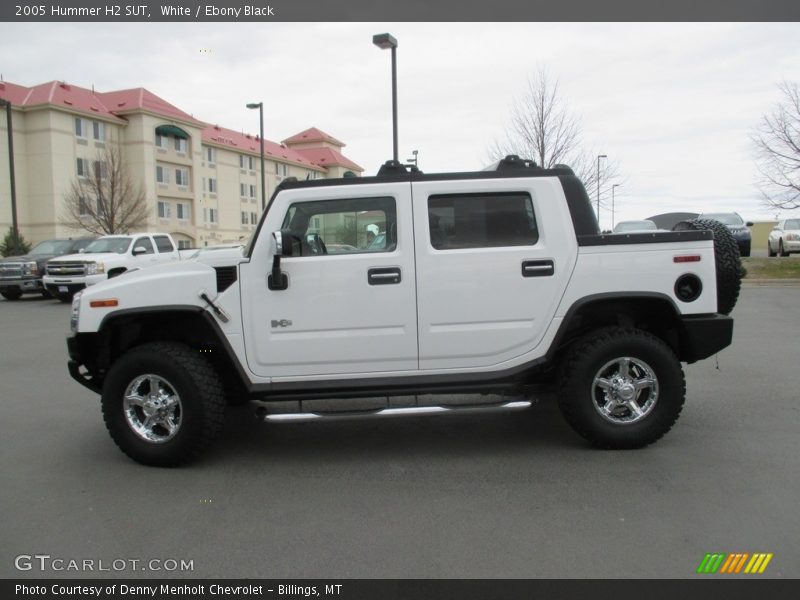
[0,23,800,227]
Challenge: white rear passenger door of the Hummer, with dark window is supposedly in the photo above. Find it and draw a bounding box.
[412,178,577,370]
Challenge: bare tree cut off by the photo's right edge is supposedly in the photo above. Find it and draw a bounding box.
[751,81,800,210]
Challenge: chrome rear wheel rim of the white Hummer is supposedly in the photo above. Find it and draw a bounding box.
[592,356,658,425]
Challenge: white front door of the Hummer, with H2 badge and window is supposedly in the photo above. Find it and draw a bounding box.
[241,184,418,381]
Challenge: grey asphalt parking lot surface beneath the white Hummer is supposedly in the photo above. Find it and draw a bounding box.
[0,287,800,578]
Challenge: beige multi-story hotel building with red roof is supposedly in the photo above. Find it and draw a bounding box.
[0,81,363,247]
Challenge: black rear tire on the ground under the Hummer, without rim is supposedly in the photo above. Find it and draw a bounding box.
[558,327,686,449]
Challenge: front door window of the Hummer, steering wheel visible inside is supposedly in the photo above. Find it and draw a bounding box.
[283,197,397,256]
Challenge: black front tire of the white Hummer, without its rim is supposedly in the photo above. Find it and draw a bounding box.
[101,342,225,467]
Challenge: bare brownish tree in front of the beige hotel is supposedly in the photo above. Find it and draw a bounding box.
[60,142,147,235]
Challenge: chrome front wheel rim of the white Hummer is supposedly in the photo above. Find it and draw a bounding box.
[123,373,183,444]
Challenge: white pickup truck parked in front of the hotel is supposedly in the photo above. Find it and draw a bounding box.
[42,233,180,302]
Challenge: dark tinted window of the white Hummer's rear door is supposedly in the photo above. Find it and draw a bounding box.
[428,193,539,250]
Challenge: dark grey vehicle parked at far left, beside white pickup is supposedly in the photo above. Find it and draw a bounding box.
[0,238,94,300]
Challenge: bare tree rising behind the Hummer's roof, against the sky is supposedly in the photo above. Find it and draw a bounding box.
[489,68,619,205]
